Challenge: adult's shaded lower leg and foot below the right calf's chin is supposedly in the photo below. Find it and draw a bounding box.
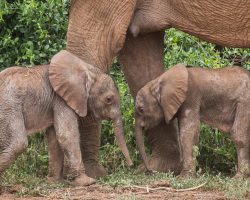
[138,121,182,175]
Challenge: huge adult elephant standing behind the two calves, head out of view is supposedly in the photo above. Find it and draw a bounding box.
[47,0,250,180]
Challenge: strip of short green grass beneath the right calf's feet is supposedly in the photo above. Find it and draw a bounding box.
[99,170,250,199]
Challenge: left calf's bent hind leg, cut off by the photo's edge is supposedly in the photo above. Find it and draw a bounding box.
[0,115,28,175]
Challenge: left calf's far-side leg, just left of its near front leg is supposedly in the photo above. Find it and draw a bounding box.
[46,126,64,182]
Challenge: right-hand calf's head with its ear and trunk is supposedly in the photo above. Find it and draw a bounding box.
[135,64,188,170]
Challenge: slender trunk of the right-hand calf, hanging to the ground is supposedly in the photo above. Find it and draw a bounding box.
[135,120,150,171]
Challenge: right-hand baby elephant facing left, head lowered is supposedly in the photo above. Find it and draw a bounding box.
[136,64,250,177]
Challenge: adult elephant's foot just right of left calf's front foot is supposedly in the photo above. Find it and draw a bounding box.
[84,161,108,179]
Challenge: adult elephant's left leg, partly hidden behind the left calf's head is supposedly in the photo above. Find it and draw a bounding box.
[59,0,136,178]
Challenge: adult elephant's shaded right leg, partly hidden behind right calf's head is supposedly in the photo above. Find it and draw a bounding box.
[119,32,181,174]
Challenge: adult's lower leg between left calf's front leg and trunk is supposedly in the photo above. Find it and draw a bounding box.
[79,117,107,178]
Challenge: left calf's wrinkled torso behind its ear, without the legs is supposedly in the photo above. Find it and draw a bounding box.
[0,65,55,133]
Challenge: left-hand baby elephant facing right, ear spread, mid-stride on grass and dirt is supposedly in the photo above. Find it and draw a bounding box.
[0,51,132,185]
